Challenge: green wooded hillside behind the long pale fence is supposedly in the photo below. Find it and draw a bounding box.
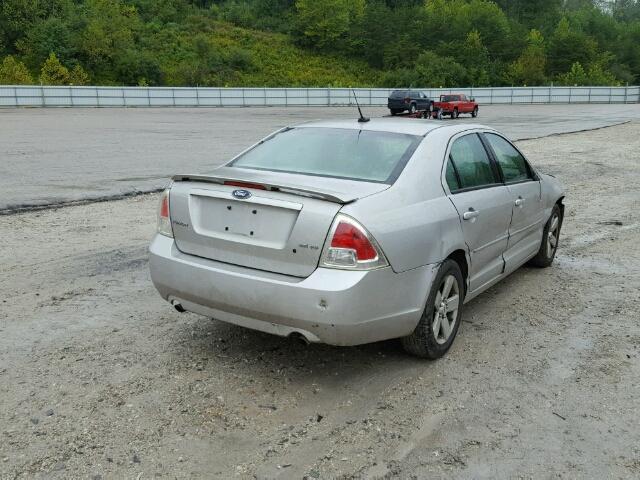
[0,0,640,87]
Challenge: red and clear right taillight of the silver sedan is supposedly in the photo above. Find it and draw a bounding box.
[320,213,389,270]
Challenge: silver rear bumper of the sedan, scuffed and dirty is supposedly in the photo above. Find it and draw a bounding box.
[149,235,434,345]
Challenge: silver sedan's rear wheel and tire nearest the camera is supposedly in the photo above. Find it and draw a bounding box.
[401,259,464,360]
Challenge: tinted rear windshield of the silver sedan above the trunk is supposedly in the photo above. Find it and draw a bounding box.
[229,127,422,183]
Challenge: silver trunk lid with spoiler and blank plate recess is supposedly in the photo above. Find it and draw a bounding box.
[170,167,388,277]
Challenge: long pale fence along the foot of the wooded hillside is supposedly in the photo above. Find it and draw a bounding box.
[0,85,640,107]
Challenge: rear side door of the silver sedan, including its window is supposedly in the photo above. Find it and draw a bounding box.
[445,133,513,292]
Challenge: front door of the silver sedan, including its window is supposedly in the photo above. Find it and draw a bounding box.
[483,132,544,271]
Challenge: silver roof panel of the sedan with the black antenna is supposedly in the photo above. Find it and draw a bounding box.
[294,117,493,137]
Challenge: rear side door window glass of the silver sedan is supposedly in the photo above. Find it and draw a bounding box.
[446,133,498,192]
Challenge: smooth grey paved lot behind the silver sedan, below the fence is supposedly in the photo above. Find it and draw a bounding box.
[0,104,640,213]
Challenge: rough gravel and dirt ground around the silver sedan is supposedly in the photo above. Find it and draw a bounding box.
[0,122,640,480]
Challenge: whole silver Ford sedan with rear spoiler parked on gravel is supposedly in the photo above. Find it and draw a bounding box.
[150,119,564,358]
